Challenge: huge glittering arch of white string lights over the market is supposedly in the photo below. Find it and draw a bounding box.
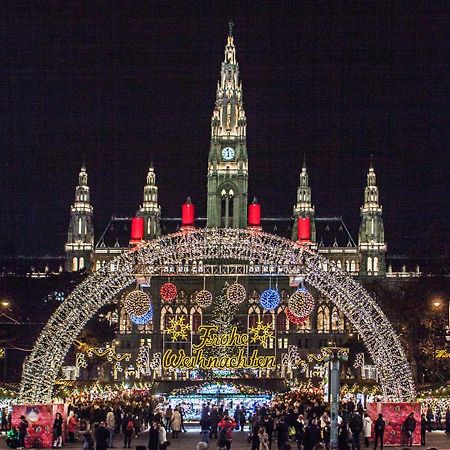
[20,228,415,403]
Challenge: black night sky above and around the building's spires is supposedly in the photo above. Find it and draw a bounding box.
[0,1,450,255]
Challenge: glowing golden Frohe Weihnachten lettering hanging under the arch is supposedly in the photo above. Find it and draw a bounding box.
[162,325,276,370]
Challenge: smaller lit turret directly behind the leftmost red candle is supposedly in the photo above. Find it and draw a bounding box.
[136,164,161,240]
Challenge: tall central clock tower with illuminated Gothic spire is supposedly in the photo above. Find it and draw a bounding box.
[207,22,248,228]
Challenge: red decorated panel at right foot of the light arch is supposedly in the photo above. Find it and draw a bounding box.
[367,402,420,446]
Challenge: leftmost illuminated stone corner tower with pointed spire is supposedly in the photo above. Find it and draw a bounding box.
[65,164,94,272]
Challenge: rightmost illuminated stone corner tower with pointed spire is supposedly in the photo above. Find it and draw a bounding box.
[358,162,386,276]
